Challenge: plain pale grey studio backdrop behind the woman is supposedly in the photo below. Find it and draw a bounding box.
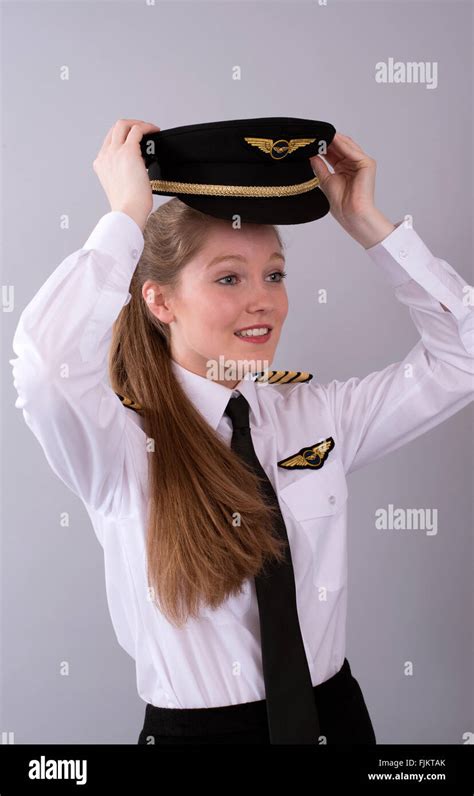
[0,0,474,744]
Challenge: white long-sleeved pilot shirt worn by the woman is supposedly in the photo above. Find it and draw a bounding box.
[10,211,474,708]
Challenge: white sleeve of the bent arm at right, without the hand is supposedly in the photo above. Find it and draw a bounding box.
[323,222,474,473]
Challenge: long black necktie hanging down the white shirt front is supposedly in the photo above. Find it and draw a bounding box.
[225,395,320,744]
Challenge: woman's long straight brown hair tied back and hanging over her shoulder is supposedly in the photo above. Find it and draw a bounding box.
[109,197,284,626]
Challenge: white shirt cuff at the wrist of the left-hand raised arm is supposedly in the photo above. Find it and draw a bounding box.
[82,210,145,265]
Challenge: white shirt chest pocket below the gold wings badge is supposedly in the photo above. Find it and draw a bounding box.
[279,459,348,600]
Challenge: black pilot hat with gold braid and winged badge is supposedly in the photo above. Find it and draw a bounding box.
[140,116,336,224]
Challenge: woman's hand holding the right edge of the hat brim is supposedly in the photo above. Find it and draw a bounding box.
[310,133,395,249]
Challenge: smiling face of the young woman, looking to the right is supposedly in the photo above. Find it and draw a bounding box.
[143,220,288,389]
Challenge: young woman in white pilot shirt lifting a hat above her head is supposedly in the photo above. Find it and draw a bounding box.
[10,119,473,744]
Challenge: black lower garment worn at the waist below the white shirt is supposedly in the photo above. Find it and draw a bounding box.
[138,658,376,745]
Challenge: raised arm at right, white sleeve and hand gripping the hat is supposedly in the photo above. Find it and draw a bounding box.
[311,133,474,473]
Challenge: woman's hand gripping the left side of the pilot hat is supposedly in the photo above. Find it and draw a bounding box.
[92,119,160,232]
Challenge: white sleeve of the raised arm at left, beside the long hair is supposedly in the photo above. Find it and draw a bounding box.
[9,211,148,514]
